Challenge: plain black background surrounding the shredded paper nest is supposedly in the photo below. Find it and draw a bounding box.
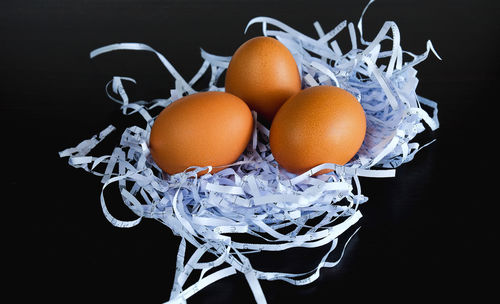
[0,0,500,303]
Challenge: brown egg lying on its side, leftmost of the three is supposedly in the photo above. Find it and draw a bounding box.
[149,92,253,174]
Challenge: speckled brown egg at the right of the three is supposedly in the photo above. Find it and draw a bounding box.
[269,85,366,174]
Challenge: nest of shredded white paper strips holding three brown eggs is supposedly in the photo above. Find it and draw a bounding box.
[60,2,439,303]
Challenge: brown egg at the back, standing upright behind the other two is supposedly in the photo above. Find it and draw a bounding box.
[225,37,301,122]
